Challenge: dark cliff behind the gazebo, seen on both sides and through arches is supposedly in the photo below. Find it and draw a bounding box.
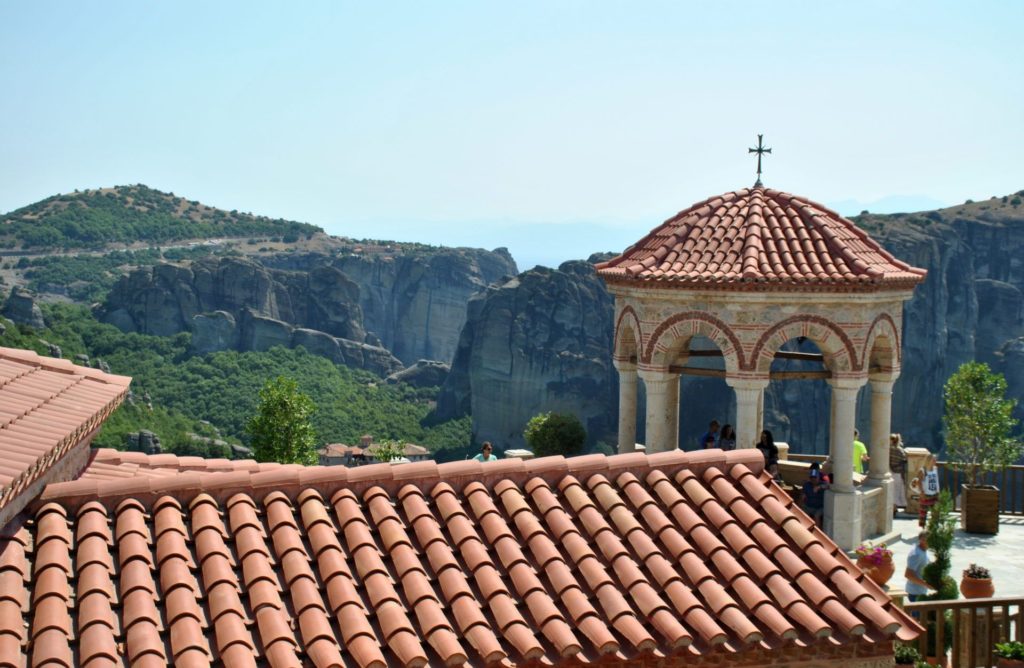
[437,192,1024,452]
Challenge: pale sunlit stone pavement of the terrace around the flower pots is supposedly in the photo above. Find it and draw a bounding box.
[889,513,1024,597]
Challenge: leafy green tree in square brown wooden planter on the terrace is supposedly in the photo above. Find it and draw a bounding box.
[943,362,1021,534]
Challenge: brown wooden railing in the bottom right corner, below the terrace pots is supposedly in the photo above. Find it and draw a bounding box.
[904,598,1024,668]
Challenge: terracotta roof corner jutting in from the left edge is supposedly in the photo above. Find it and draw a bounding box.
[0,347,131,524]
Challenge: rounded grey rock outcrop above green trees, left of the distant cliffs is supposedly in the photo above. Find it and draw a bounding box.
[99,258,402,375]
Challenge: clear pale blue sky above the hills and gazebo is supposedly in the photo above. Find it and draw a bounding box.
[0,0,1024,266]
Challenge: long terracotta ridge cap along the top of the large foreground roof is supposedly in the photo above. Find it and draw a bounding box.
[36,449,764,516]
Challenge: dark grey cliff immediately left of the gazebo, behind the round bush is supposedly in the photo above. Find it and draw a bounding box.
[437,261,617,448]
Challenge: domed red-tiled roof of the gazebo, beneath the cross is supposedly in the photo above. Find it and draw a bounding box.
[597,187,927,291]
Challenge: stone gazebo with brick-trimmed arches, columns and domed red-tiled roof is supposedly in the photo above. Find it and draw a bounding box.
[597,180,926,549]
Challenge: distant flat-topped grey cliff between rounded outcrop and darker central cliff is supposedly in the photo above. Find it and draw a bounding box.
[264,247,517,365]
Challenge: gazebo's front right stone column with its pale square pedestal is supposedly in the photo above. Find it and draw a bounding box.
[825,378,866,550]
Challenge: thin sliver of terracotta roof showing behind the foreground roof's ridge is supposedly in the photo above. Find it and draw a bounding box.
[79,448,290,481]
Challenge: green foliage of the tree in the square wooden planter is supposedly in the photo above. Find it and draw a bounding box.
[943,362,1021,487]
